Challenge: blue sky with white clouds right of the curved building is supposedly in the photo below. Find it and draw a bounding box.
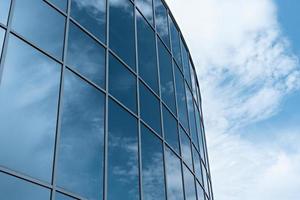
[167,0,300,200]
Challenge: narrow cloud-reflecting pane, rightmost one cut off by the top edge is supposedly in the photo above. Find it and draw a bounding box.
[154,0,170,48]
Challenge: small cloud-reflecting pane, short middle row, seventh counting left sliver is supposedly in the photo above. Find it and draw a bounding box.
[179,127,193,169]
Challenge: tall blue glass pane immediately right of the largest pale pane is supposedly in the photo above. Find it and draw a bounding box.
[57,70,104,200]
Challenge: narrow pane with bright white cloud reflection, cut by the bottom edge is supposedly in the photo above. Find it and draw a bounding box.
[165,148,184,200]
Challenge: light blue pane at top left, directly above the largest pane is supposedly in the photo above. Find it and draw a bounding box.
[12,0,65,59]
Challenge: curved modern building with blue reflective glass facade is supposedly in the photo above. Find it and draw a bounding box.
[0,0,213,200]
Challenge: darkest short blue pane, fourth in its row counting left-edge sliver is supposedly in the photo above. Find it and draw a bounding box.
[109,54,137,112]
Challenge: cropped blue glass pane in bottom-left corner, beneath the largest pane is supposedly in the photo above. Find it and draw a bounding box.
[0,173,50,200]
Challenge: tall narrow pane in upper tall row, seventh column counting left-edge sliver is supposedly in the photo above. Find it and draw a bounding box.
[174,66,189,130]
